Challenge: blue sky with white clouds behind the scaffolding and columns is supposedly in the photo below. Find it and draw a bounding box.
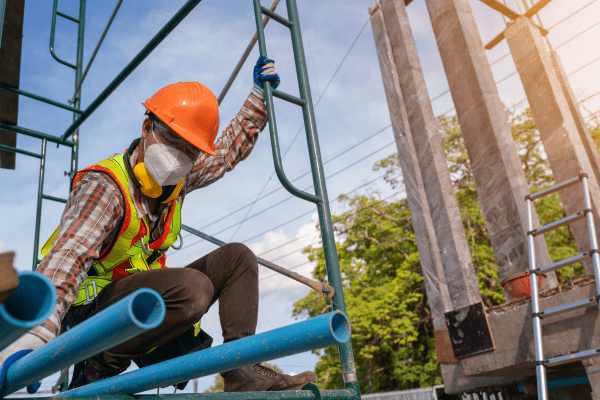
[0,0,600,390]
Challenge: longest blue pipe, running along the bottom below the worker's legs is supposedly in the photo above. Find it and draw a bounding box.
[58,311,350,396]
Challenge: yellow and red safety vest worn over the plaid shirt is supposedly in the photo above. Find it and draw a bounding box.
[41,154,181,306]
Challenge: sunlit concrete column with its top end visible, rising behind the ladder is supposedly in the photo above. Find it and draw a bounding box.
[505,18,600,274]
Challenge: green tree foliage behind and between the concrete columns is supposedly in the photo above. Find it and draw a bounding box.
[294,110,600,393]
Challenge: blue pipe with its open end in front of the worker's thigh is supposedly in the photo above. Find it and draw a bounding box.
[0,289,166,397]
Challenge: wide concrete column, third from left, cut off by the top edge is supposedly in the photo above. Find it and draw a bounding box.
[426,0,557,287]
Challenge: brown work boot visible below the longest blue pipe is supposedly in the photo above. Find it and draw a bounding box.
[221,364,317,392]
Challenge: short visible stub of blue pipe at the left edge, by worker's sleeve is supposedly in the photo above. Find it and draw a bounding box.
[0,271,56,350]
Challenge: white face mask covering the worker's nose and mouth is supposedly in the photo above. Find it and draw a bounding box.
[144,143,194,186]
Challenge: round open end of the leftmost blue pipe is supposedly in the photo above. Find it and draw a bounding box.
[0,272,56,328]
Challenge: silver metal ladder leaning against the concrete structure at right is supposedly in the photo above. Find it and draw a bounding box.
[525,173,600,400]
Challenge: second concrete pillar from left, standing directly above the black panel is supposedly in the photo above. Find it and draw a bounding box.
[381,0,481,310]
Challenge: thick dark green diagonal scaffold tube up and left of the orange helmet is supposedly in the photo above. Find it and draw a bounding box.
[60,0,201,140]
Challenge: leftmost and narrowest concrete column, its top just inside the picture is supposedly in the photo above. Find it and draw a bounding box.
[371,7,452,330]
